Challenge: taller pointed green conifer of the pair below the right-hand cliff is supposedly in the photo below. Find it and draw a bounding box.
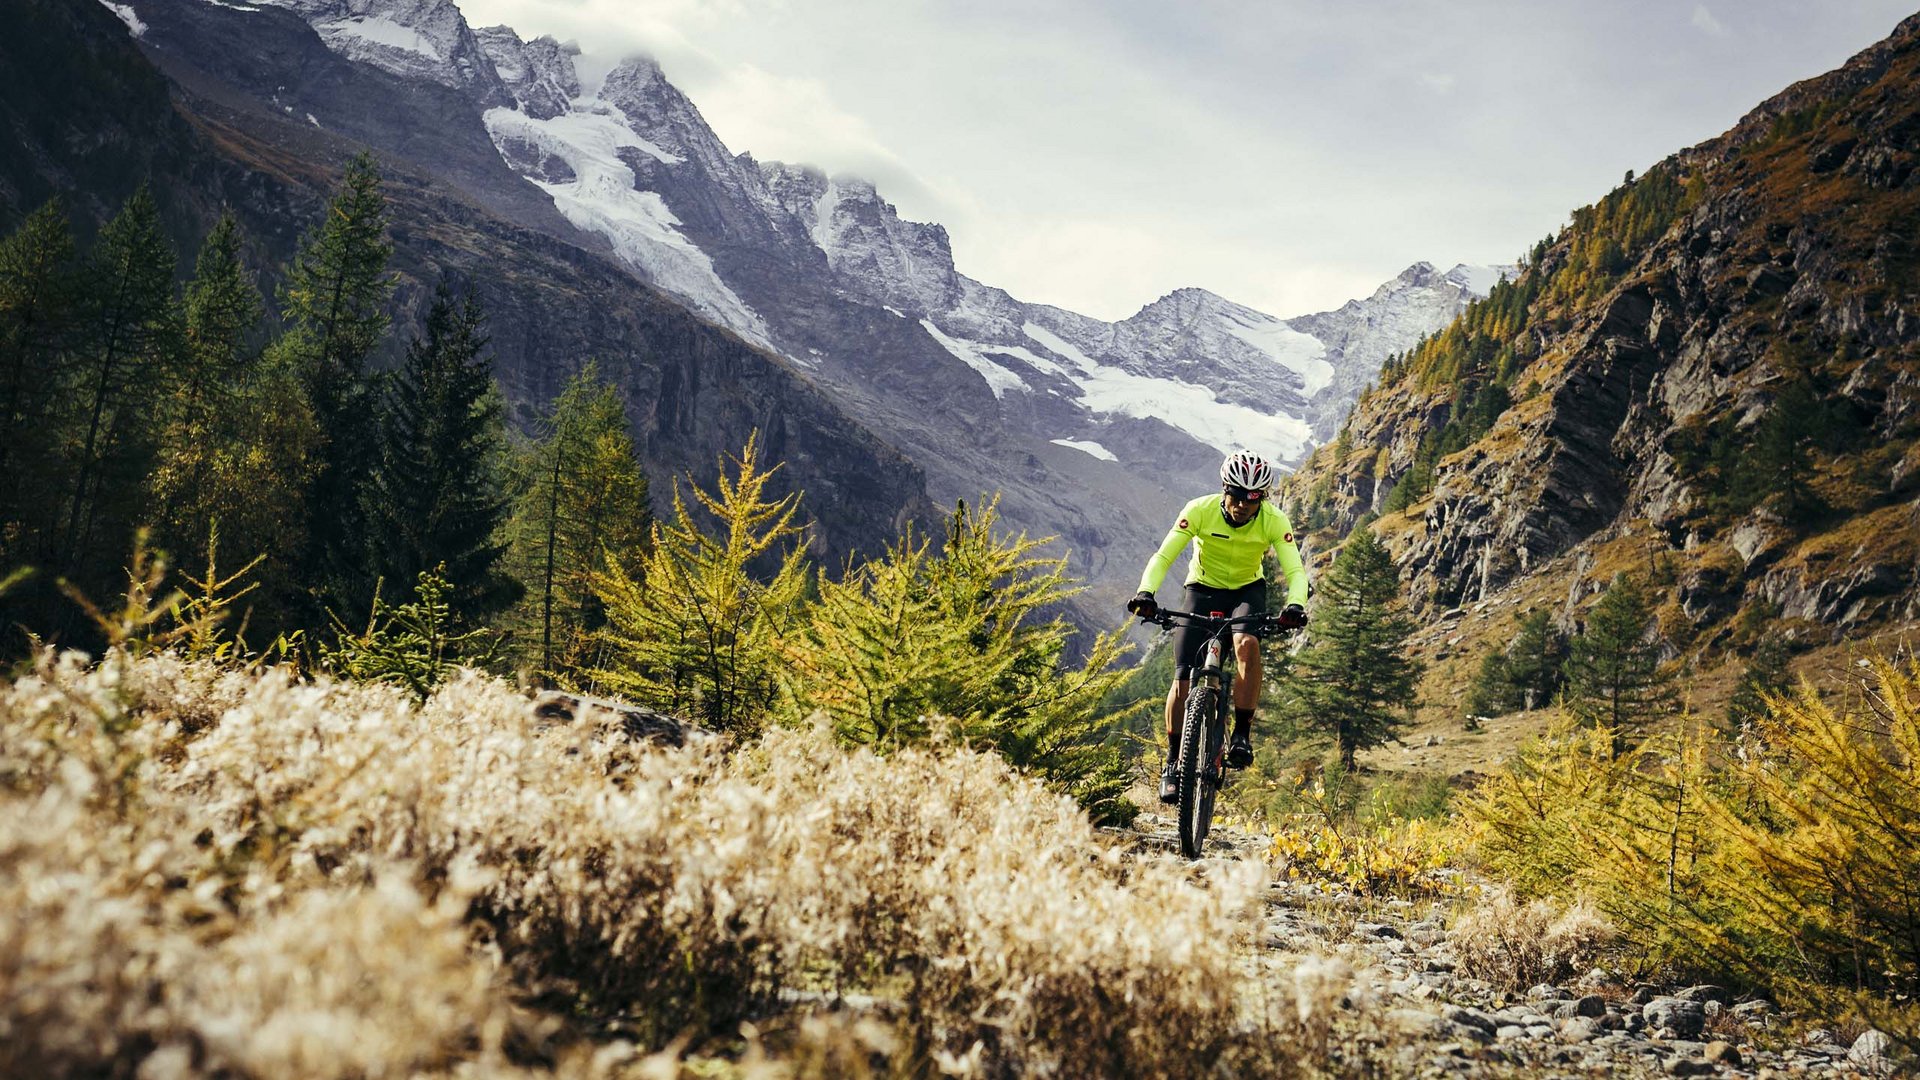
[1567,575,1672,755]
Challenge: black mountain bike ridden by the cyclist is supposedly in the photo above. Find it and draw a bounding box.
[1146,607,1284,859]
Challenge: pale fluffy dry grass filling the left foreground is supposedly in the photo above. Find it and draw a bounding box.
[0,641,1390,1076]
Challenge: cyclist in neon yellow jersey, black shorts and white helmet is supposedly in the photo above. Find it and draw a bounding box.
[1127,450,1308,803]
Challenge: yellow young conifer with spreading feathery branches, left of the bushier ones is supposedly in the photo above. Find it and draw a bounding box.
[589,432,808,732]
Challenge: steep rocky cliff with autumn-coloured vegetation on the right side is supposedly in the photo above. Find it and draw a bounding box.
[1290,17,1920,642]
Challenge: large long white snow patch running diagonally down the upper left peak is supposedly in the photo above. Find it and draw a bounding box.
[482,102,768,346]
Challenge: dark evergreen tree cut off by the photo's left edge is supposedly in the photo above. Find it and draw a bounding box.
[0,202,79,569]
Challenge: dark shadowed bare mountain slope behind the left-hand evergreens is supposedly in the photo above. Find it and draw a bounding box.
[0,0,933,561]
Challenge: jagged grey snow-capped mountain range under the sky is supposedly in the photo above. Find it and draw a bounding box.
[120,0,1496,622]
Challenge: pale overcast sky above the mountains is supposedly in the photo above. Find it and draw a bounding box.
[457,0,1914,319]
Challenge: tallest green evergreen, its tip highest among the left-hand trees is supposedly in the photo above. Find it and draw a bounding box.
[275,154,394,628]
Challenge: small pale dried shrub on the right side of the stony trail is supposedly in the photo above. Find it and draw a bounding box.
[1452,890,1615,992]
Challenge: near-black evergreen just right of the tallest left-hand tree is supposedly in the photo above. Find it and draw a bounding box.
[367,281,520,626]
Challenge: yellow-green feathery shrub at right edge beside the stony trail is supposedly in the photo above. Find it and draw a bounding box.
[1465,661,1920,1045]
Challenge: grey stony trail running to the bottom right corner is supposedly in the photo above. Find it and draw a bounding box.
[1114,813,1914,1078]
